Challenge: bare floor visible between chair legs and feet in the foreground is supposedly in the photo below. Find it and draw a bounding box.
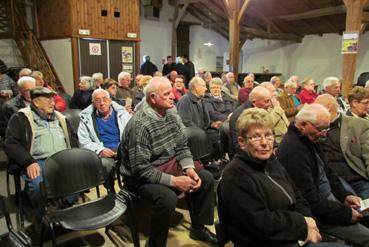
[0,150,233,247]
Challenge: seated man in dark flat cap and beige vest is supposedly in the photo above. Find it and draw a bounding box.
[5,87,75,220]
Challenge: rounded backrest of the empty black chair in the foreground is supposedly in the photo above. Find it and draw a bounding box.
[41,148,106,199]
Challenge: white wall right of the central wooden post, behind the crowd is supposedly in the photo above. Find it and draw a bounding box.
[242,33,369,83]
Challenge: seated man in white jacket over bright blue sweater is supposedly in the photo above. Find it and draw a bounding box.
[78,89,131,189]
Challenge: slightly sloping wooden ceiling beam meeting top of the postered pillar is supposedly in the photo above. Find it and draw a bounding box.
[271,5,346,21]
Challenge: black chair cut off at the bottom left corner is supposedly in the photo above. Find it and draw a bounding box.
[0,196,32,247]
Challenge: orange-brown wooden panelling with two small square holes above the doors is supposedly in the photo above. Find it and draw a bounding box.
[70,0,140,40]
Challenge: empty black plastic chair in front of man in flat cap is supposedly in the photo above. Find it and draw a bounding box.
[40,148,133,246]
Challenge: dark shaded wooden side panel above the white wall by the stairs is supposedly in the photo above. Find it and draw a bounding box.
[36,0,72,39]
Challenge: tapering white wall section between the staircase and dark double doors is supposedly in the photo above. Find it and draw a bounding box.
[41,39,74,95]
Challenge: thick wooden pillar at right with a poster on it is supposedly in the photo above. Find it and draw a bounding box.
[342,0,367,96]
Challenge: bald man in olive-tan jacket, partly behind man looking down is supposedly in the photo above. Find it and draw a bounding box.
[315,94,369,199]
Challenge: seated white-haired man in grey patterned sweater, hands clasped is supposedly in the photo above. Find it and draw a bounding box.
[121,77,217,247]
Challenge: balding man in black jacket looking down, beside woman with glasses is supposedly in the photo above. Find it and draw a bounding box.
[278,103,369,246]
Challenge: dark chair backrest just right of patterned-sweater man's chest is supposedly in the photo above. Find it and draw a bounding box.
[183,127,212,160]
